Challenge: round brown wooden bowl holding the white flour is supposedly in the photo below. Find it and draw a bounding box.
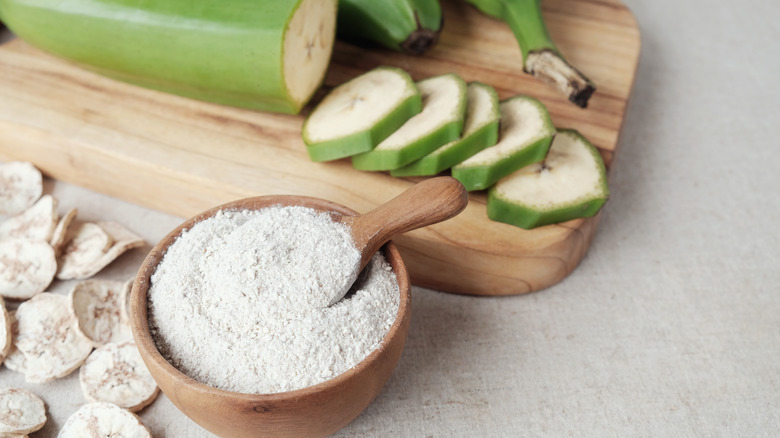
[130,196,411,437]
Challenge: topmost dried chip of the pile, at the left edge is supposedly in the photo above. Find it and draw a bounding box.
[0,161,43,214]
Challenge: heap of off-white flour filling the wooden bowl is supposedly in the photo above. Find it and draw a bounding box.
[148,206,400,394]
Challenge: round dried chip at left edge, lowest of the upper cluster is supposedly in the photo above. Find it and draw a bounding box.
[0,239,57,300]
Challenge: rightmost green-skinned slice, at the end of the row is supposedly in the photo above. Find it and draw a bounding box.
[487,130,609,229]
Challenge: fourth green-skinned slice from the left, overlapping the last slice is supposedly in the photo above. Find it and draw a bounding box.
[452,96,555,191]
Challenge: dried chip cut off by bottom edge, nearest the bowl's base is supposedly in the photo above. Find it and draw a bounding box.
[58,402,152,438]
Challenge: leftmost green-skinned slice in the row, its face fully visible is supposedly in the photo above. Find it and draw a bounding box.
[303,67,422,161]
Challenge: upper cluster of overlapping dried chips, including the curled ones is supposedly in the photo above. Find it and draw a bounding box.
[0,162,145,300]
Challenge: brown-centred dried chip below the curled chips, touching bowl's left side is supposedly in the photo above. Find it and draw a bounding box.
[69,280,133,347]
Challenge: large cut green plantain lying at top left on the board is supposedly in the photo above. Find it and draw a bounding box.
[0,0,337,114]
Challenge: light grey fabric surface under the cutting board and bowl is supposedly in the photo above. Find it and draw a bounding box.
[0,0,780,437]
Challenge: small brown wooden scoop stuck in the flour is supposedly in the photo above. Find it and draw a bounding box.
[330,176,468,305]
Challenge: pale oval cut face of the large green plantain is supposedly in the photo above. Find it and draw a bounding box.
[282,0,337,108]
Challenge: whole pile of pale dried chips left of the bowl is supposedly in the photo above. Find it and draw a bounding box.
[0,162,159,437]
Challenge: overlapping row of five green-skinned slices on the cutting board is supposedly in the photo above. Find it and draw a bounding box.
[303,67,609,229]
